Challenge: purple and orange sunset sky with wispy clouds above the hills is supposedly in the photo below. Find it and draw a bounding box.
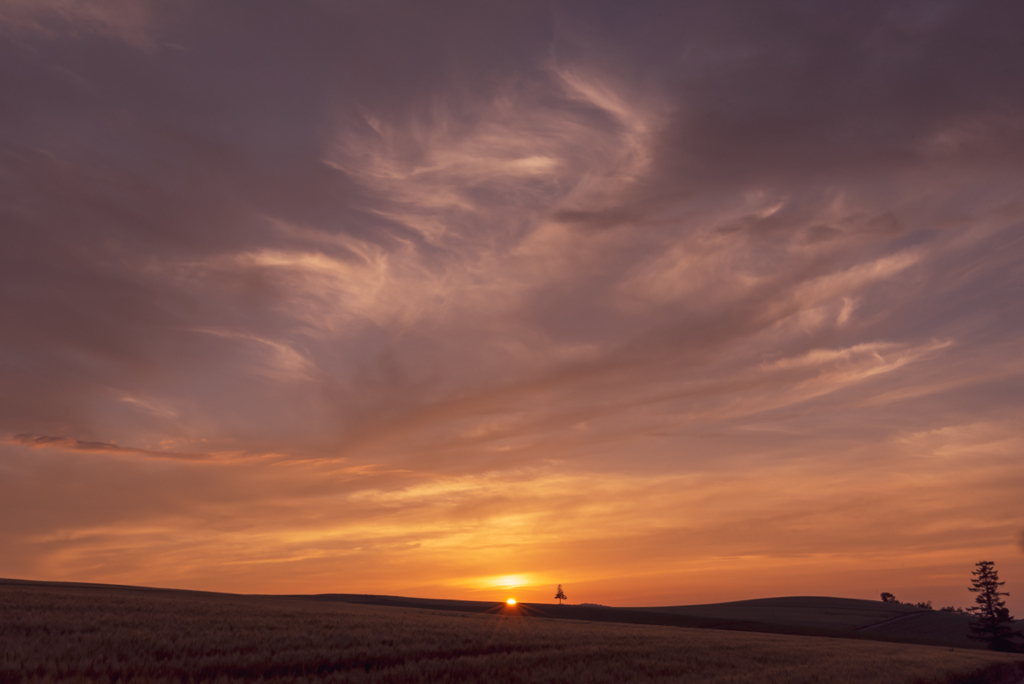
[0,0,1024,614]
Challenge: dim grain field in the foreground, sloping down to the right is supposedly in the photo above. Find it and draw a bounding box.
[0,583,1024,684]
